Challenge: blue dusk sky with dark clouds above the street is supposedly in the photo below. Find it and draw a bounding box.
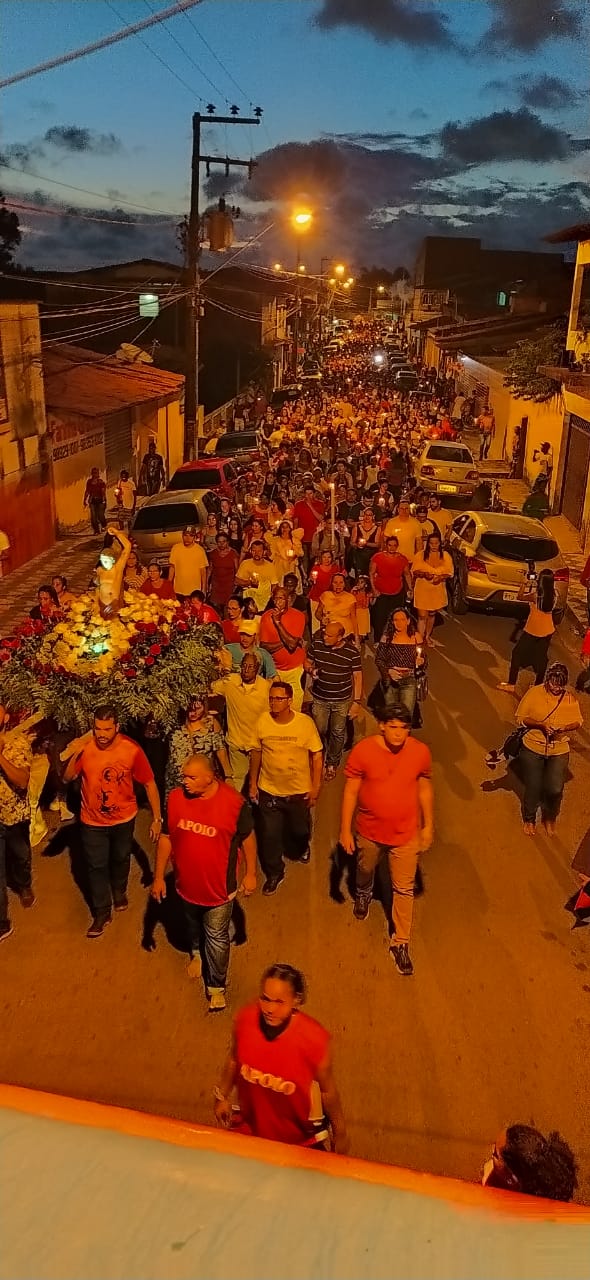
[0,0,590,270]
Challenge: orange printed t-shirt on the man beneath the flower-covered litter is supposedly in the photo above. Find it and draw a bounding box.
[76,733,154,827]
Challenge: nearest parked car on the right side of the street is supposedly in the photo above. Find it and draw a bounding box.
[448,511,570,621]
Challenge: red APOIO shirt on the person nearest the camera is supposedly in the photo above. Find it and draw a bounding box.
[234,1004,330,1146]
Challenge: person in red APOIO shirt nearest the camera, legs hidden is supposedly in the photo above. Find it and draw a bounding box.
[214,964,348,1153]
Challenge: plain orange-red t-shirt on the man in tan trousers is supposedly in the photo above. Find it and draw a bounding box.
[344,737,433,846]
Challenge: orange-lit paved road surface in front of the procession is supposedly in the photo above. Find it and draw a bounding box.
[0,616,590,1198]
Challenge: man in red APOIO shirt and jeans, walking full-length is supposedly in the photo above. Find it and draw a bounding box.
[150,755,256,1012]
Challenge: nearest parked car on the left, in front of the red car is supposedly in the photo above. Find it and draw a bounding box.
[131,489,219,564]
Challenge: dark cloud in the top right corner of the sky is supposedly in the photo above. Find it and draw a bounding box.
[482,0,585,52]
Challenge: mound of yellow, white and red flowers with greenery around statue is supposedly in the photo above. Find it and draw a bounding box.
[0,591,220,733]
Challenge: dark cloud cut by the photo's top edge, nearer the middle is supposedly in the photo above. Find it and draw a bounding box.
[314,0,457,50]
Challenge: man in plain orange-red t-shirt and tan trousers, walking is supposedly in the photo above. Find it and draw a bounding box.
[339,707,433,975]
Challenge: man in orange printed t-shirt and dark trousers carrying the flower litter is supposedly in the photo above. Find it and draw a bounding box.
[64,707,161,938]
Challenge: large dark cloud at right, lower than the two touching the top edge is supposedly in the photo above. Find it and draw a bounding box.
[439,108,578,165]
